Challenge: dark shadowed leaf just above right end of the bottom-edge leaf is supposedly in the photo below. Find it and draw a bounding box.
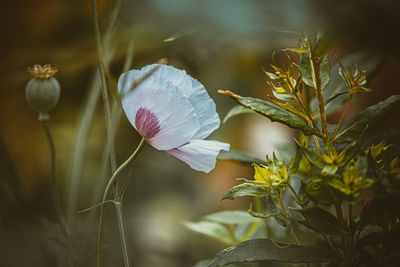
[297,207,349,235]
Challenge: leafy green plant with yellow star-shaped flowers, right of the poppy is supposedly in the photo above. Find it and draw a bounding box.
[191,32,400,266]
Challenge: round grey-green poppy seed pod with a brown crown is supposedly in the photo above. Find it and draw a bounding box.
[25,65,61,121]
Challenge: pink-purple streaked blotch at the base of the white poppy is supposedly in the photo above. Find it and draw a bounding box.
[135,108,161,140]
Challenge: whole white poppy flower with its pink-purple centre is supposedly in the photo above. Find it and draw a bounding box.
[118,64,230,173]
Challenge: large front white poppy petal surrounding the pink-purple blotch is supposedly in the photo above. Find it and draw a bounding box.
[118,70,200,150]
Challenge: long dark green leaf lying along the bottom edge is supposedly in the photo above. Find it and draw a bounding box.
[208,239,336,267]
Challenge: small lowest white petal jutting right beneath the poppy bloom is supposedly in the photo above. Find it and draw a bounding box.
[167,139,230,173]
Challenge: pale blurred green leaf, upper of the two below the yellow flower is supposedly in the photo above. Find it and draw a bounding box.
[203,210,260,224]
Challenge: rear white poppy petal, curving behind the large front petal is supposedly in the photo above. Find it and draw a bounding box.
[135,64,221,139]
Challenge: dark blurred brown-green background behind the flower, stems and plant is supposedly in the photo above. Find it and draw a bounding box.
[0,0,400,267]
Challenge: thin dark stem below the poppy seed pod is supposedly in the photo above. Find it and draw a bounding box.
[42,121,72,266]
